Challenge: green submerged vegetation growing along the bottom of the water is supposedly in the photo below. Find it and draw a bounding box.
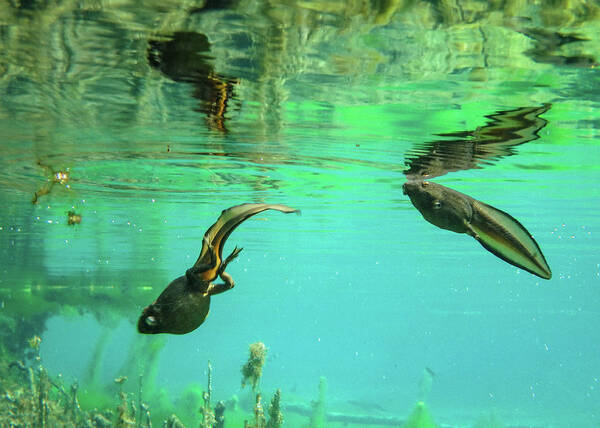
[0,326,541,428]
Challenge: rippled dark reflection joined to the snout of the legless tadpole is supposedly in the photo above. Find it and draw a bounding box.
[404,104,551,179]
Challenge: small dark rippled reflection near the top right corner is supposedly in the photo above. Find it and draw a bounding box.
[518,28,598,67]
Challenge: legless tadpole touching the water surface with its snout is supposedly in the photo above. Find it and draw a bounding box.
[402,181,552,279]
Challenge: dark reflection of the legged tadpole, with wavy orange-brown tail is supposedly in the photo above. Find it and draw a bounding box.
[148,31,237,132]
